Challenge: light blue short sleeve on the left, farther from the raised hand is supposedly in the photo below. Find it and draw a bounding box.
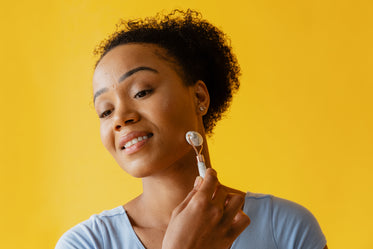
[55,219,104,249]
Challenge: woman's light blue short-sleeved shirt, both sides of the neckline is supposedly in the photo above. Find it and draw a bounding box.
[55,192,326,249]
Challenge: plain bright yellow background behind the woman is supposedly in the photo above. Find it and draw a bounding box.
[0,0,373,249]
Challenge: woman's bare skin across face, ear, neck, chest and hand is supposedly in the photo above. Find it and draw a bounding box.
[93,44,326,249]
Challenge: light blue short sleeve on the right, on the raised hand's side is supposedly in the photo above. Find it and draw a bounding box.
[272,197,326,249]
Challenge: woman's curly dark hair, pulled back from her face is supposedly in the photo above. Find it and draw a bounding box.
[94,9,240,134]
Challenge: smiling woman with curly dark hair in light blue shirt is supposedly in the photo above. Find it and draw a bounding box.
[56,10,326,249]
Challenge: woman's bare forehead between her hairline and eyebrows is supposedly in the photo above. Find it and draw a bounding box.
[93,43,181,90]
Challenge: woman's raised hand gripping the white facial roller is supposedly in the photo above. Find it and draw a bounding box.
[162,168,250,249]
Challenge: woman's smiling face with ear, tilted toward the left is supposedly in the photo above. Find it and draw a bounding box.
[93,44,209,177]
